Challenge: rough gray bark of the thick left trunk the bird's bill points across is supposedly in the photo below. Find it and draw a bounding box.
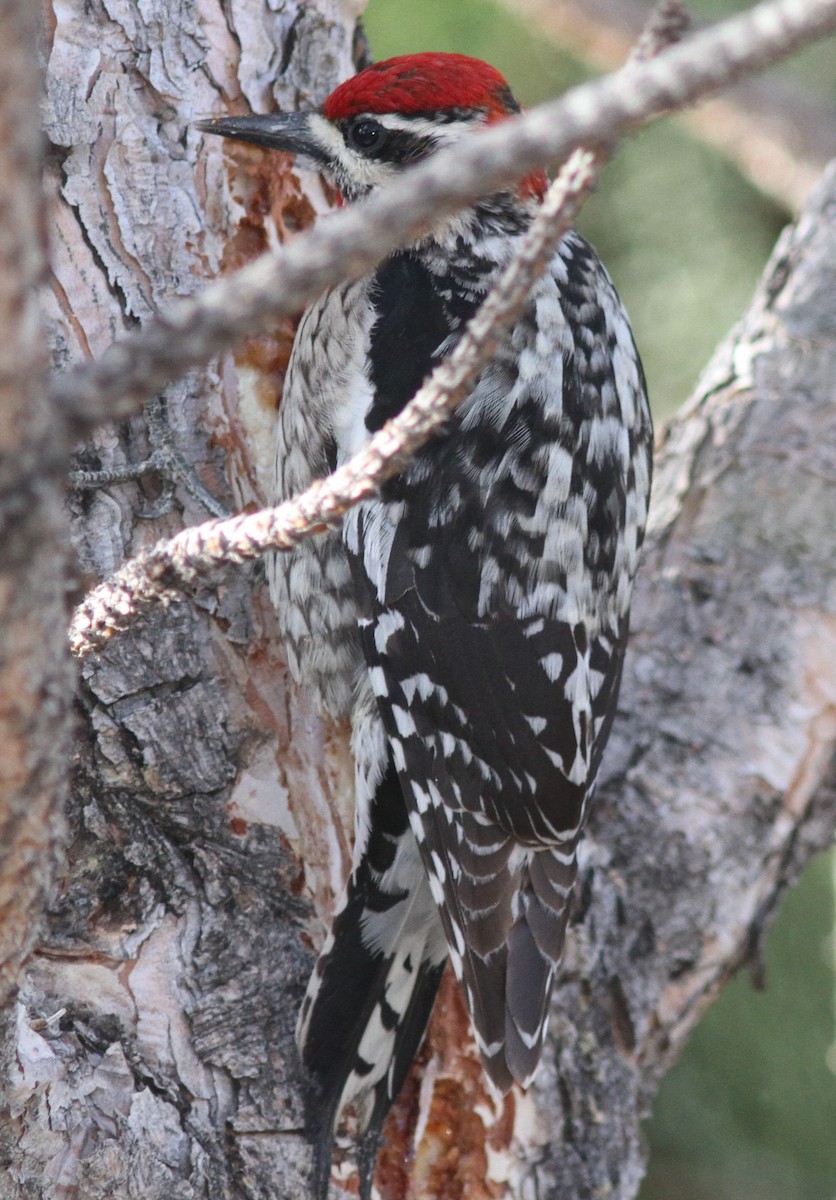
[0,0,354,1200]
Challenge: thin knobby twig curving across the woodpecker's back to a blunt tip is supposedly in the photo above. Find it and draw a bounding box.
[70,4,834,656]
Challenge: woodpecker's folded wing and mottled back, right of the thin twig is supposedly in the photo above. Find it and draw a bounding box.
[344,231,650,1090]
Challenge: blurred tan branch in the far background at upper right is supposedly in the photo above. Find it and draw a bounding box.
[505,0,836,212]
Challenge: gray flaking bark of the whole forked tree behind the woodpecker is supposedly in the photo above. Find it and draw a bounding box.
[0,0,836,1200]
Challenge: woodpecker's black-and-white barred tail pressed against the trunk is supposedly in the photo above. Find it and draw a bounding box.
[296,764,447,1200]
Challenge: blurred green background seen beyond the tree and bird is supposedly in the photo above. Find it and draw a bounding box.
[365,0,836,1200]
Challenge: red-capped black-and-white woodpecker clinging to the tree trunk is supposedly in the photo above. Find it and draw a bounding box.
[199,53,652,1196]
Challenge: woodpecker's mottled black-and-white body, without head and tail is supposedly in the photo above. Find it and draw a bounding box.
[271,223,650,1123]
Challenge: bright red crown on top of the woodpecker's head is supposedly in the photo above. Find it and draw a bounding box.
[323,53,519,121]
